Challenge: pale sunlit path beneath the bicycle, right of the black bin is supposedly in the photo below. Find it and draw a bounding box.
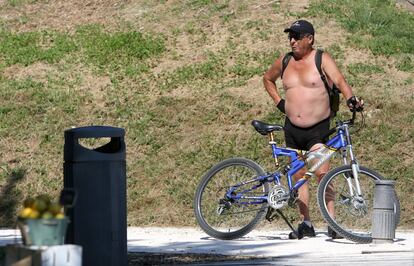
[128,227,414,260]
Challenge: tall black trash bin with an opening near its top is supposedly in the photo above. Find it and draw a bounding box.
[64,126,127,266]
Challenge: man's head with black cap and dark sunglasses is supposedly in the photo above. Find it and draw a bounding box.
[284,19,315,54]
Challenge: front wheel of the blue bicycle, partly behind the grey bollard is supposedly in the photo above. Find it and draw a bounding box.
[318,165,401,243]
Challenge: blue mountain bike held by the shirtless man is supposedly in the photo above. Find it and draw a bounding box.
[194,111,400,243]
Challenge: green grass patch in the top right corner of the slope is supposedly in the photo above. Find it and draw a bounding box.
[307,0,414,60]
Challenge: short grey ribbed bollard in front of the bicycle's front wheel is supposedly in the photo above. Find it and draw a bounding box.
[372,180,395,244]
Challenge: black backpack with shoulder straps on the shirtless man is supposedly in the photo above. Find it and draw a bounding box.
[280,49,341,117]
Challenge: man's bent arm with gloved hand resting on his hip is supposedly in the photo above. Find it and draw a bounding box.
[263,55,285,113]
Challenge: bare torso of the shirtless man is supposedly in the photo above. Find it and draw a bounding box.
[282,50,330,128]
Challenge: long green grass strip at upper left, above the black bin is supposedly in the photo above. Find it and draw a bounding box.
[0,25,165,76]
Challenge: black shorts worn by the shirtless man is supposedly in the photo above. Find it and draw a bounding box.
[285,117,330,151]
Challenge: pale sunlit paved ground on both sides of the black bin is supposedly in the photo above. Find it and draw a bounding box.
[0,227,414,266]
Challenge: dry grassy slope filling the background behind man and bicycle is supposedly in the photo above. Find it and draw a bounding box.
[0,0,414,228]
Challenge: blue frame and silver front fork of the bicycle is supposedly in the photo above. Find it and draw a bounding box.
[226,113,362,204]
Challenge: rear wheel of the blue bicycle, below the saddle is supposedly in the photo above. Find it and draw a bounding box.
[194,158,269,240]
